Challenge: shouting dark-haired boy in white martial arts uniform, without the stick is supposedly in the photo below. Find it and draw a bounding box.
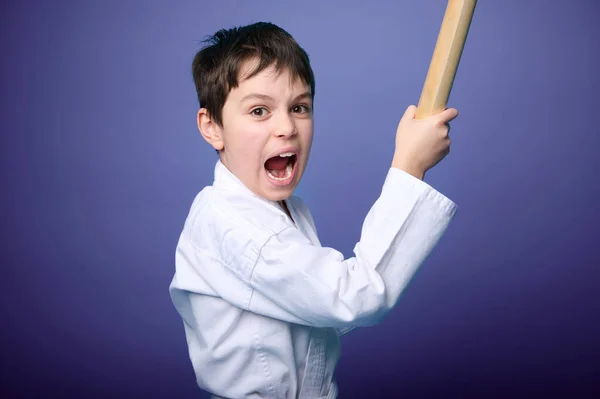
[170,23,457,399]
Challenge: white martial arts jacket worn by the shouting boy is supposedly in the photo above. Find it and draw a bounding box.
[170,161,457,399]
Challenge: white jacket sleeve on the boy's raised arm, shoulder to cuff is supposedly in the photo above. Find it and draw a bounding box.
[223,169,456,329]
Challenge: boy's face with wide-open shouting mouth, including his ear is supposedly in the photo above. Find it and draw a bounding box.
[198,60,313,201]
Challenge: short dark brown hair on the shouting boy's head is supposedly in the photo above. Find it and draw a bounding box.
[192,22,315,126]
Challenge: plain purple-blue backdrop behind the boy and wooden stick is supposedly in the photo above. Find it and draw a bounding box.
[0,0,600,398]
